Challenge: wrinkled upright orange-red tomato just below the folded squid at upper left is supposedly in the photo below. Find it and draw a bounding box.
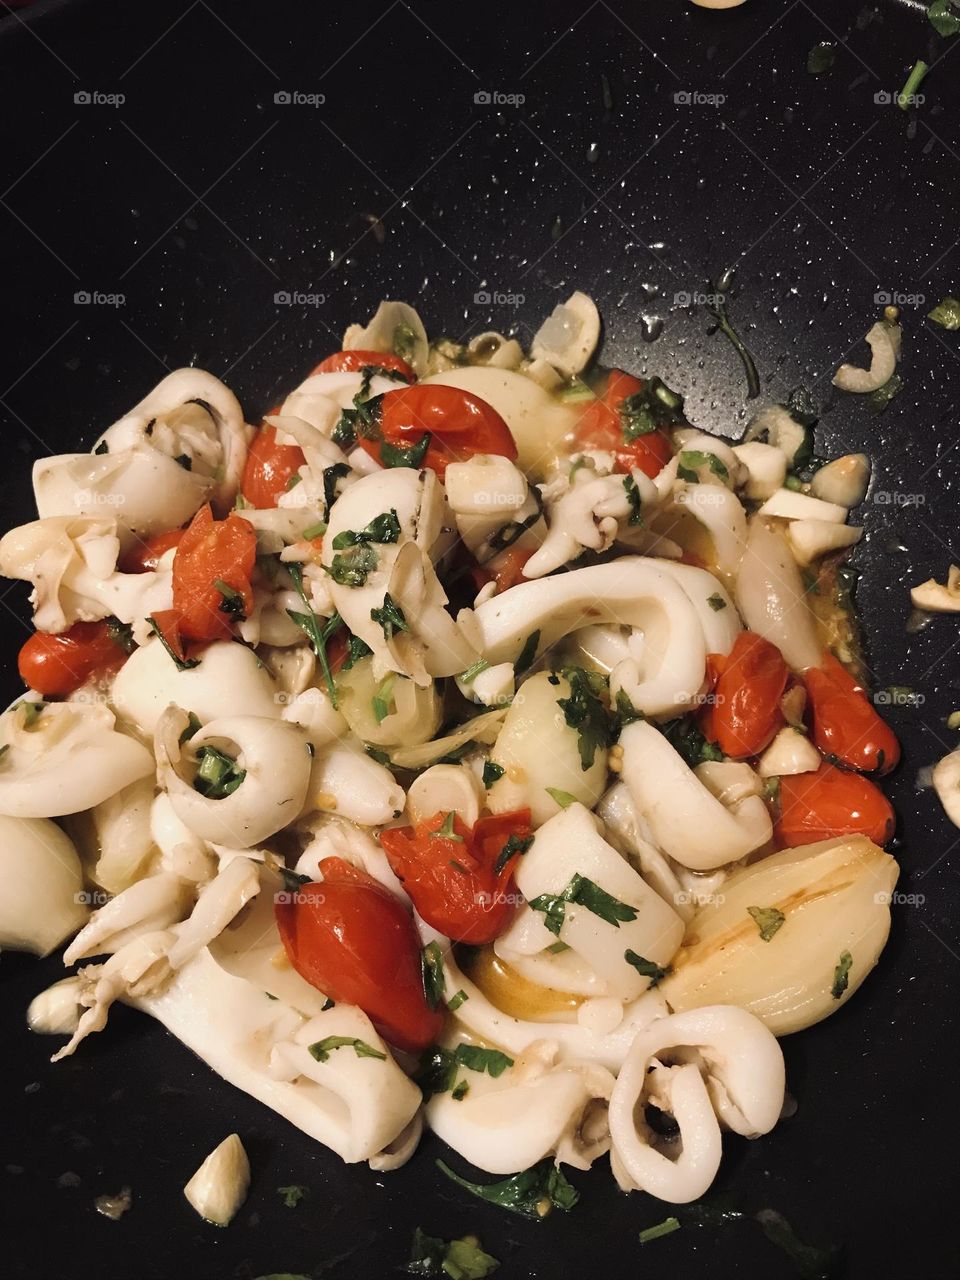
[173,504,257,640]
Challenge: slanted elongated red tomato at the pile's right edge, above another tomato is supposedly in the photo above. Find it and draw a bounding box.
[804,650,900,774]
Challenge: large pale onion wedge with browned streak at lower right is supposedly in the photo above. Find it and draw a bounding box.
[659,836,900,1036]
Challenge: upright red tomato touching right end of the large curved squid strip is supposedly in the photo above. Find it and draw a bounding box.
[703,631,790,760]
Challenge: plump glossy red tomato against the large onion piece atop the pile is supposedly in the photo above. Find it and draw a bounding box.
[357,383,517,480]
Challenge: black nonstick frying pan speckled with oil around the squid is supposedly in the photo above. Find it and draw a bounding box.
[0,0,960,1280]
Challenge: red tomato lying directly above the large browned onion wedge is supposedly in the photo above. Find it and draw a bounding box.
[774,763,896,849]
